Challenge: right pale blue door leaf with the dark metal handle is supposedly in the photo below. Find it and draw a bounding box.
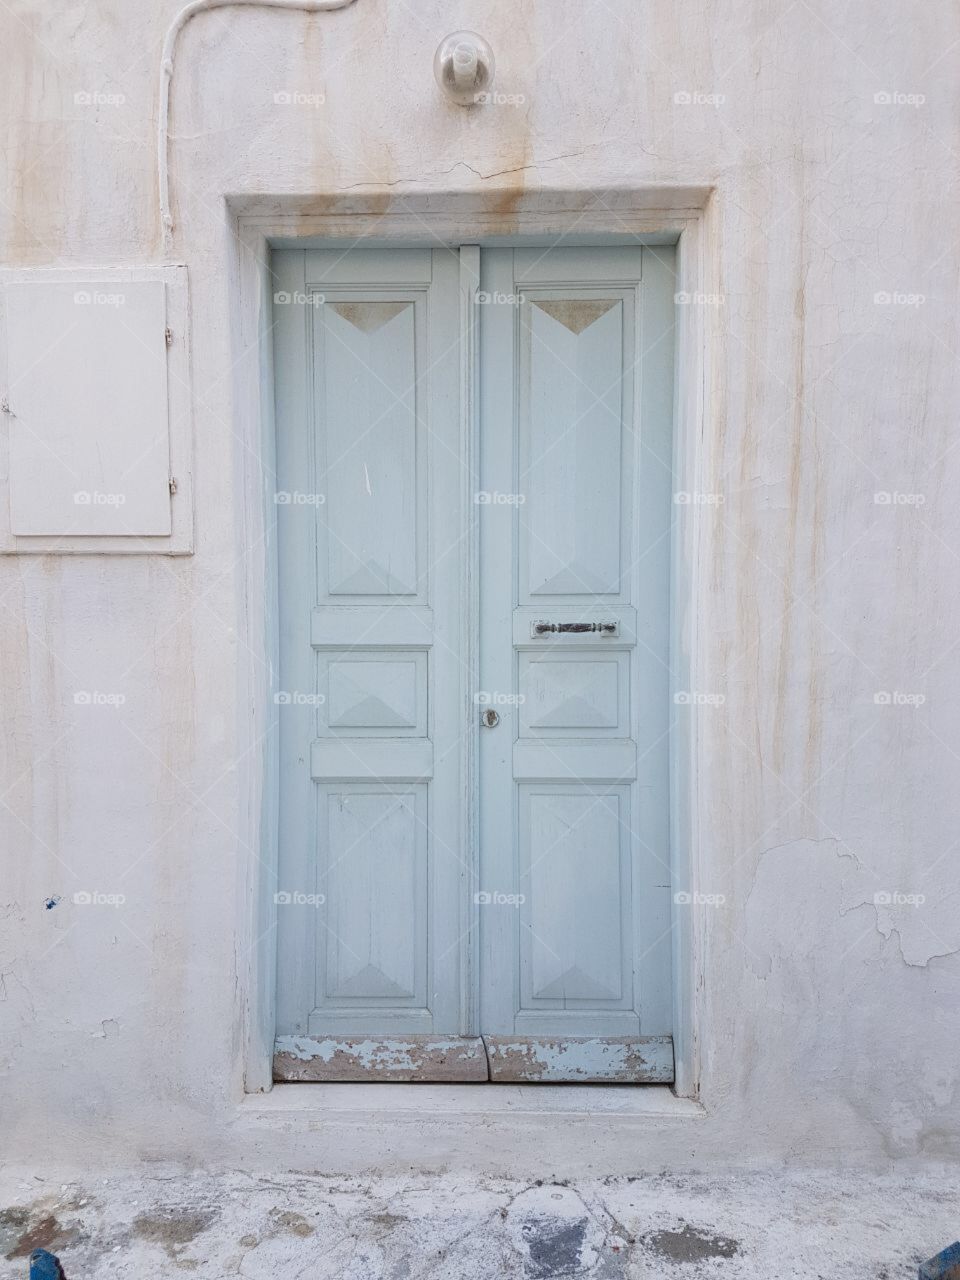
[480,248,672,1080]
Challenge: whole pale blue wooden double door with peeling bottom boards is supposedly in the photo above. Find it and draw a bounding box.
[275,247,673,1080]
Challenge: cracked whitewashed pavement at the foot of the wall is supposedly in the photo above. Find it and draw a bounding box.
[0,1167,956,1280]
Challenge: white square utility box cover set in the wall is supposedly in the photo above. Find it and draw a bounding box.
[0,268,191,553]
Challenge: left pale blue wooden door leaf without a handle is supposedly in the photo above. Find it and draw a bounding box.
[275,250,471,1079]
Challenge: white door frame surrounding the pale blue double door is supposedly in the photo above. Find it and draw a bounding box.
[225,187,721,1098]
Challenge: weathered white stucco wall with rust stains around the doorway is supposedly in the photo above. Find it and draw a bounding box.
[0,0,960,1172]
